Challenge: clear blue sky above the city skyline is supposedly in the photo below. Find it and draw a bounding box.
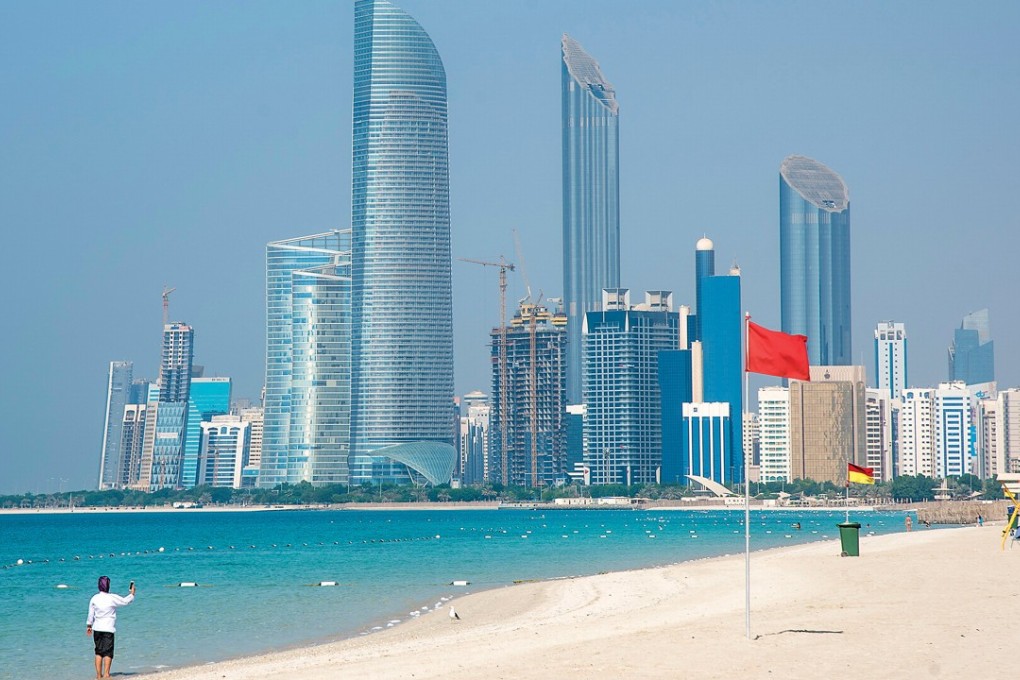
[0,0,1020,492]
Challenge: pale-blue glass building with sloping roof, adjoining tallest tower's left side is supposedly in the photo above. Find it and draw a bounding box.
[259,230,351,487]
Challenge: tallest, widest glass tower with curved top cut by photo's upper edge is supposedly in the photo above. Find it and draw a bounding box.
[350,0,456,483]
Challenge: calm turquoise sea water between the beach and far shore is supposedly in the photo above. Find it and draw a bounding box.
[0,510,904,678]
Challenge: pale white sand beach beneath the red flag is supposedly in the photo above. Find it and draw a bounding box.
[129,524,1020,680]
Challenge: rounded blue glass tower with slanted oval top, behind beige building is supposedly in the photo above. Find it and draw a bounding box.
[779,156,851,366]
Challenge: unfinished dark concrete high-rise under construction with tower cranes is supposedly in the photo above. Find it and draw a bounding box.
[487,302,567,486]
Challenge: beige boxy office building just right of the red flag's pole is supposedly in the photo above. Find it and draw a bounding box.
[789,366,868,484]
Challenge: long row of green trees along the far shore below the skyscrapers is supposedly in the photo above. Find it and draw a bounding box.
[0,475,1004,508]
